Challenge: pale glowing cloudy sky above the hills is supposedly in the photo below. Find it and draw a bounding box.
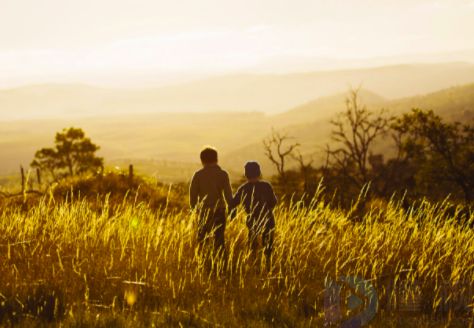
[0,0,474,87]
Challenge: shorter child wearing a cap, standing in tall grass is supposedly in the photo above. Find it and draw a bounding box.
[232,162,277,265]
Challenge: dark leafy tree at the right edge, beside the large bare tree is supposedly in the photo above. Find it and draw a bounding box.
[393,109,474,203]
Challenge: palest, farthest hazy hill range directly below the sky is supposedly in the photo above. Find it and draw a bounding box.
[0,63,474,121]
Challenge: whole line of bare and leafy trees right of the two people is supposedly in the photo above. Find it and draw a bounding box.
[263,88,474,207]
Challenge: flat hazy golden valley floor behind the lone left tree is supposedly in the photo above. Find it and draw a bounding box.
[0,112,270,175]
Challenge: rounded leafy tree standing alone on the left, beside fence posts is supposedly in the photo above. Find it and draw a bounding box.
[31,127,104,179]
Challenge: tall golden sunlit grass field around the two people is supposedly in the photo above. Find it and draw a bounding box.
[0,181,474,327]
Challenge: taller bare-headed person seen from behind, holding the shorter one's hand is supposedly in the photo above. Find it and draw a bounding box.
[189,146,232,264]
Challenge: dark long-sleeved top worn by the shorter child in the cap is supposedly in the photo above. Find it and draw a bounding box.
[232,181,277,228]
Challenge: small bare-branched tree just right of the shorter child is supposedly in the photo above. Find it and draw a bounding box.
[263,128,300,185]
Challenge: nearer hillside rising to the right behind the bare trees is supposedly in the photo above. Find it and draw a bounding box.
[226,83,474,175]
